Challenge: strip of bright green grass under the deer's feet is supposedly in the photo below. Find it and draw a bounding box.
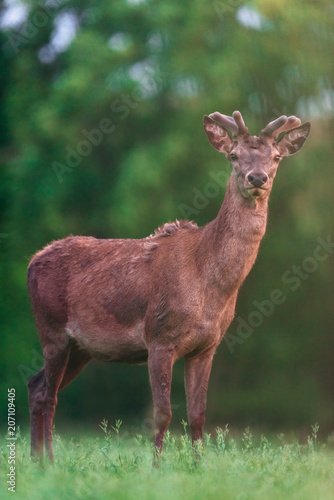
[0,422,334,500]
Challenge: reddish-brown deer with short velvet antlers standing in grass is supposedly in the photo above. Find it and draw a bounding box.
[27,111,310,461]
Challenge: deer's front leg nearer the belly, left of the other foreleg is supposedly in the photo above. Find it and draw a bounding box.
[148,347,174,456]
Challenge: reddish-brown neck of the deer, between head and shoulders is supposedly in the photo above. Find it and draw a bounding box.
[198,174,268,295]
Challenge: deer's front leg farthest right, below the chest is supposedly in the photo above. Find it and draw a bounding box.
[185,349,215,444]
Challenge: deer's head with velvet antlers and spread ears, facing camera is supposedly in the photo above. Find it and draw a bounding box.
[204,111,311,199]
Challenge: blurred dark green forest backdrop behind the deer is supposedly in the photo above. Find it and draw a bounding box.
[0,0,334,438]
